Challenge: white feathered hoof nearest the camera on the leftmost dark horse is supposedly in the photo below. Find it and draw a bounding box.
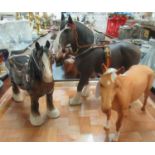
[30,114,46,126]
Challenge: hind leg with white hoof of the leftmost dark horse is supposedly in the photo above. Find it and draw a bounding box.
[11,79,23,102]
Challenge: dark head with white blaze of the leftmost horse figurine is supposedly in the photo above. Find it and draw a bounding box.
[32,41,53,83]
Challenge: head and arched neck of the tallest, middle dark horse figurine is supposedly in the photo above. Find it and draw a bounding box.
[53,16,94,65]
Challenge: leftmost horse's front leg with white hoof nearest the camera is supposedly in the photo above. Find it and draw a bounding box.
[30,96,46,126]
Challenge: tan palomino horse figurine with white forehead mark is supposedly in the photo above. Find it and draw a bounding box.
[98,65,155,141]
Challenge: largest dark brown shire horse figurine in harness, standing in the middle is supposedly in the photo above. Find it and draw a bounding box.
[53,16,140,105]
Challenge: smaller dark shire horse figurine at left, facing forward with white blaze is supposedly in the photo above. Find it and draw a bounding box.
[9,41,59,126]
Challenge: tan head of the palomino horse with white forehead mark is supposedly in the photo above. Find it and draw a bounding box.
[99,67,124,112]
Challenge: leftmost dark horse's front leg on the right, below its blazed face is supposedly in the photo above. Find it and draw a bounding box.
[46,90,60,118]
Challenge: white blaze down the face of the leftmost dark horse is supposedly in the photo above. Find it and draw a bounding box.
[42,53,53,83]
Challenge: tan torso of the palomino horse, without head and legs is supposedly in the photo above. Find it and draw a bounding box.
[116,65,154,103]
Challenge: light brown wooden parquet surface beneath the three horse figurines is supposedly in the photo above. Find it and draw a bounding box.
[0,82,155,142]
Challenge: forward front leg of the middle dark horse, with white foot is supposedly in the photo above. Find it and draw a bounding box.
[69,74,89,105]
